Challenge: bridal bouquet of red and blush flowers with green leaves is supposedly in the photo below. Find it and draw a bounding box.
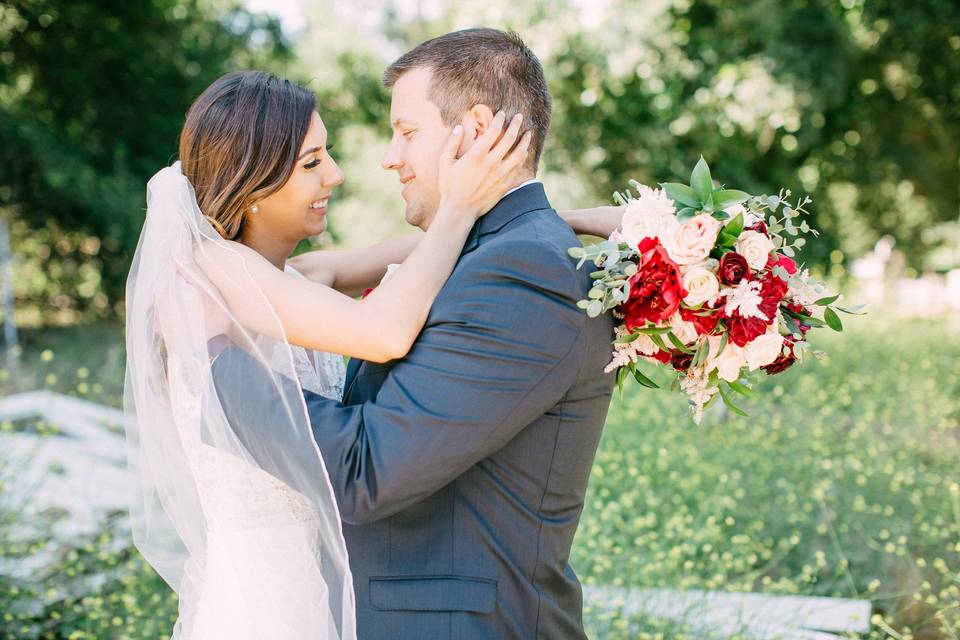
[569,158,857,424]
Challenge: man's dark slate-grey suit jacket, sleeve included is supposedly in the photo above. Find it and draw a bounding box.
[214,184,613,640]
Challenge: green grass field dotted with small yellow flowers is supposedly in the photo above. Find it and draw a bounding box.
[0,318,960,640]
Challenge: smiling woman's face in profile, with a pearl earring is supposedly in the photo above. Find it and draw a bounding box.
[248,112,343,242]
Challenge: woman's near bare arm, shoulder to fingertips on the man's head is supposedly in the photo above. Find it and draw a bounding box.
[197,115,530,362]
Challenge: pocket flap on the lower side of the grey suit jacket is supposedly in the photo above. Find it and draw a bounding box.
[370,576,497,613]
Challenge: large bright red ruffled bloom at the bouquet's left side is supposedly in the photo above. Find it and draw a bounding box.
[619,238,687,331]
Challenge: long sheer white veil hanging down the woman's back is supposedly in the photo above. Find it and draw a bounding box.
[124,163,356,640]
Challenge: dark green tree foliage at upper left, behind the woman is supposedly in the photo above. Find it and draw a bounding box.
[0,0,289,308]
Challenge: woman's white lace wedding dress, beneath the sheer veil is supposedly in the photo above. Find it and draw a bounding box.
[173,267,345,640]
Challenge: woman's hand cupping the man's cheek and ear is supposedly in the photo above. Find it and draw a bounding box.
[438,111,532,218]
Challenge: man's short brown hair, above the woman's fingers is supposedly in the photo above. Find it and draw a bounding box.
[383,29,553,172]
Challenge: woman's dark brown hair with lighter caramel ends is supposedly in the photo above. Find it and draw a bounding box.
[180,71,317,240]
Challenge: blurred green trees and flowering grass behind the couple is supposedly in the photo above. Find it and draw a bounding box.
[0,0,960,640]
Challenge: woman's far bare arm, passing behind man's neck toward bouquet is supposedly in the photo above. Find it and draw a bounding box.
[288,206,623,297]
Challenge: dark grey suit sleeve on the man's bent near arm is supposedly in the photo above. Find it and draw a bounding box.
[307,242,585,524]
